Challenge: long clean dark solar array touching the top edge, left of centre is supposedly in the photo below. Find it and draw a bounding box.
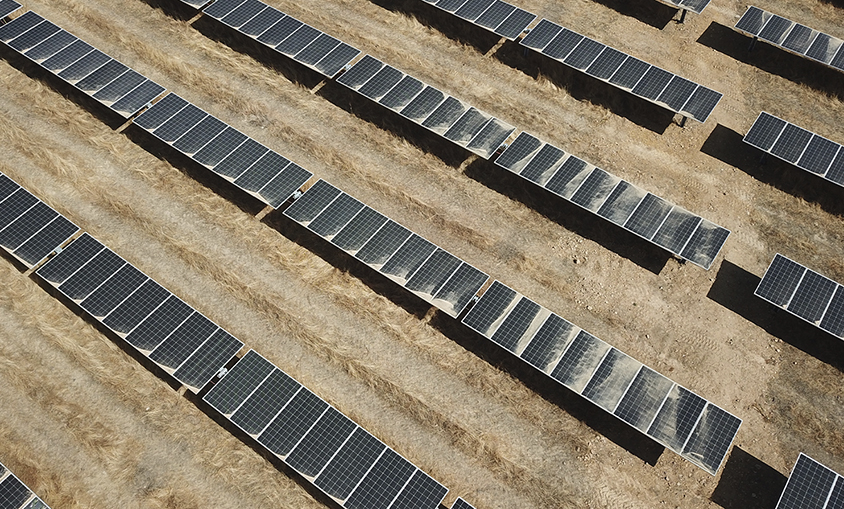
[203,0,360,78]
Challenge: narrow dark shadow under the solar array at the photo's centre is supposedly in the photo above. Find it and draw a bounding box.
[262,205,431,319]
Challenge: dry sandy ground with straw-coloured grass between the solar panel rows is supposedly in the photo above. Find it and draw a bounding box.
[0,0,844,509]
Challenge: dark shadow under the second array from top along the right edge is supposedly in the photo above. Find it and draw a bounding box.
[700,124,844,216]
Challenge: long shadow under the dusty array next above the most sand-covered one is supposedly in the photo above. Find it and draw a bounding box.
[465,158,682,274]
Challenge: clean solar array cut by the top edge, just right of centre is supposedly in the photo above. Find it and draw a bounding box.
[424,0,536,41]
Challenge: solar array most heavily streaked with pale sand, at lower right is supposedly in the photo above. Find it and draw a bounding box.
[463,281,741,475]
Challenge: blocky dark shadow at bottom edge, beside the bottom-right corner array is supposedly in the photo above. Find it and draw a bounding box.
[710,446,788,509]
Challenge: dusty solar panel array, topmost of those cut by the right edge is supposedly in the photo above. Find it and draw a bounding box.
[736,5,844,71]
